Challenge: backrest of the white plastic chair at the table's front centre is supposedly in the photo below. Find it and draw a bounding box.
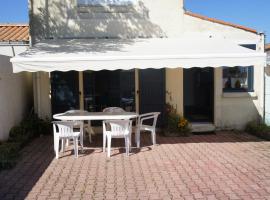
[103,120,132,137]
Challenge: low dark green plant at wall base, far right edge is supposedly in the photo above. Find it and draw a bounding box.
[245,121,270,140]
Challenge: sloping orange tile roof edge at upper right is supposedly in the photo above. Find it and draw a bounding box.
[185,11,258,33]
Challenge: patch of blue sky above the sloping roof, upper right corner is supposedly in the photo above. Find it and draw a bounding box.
[185,0,270,42]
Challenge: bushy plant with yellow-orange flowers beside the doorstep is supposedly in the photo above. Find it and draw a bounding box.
[163,104,190,136]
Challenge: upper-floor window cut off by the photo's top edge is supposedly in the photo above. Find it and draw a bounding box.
[78,0,136,6]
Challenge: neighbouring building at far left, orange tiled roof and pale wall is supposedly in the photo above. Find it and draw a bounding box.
[0,24,33,141]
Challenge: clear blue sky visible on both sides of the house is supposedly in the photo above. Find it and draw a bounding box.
[0,0,270,42]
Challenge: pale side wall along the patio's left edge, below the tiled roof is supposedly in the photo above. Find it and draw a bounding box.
[0,47,33,141]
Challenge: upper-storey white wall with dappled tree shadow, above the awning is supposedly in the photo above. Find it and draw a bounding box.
[30,0,183,41]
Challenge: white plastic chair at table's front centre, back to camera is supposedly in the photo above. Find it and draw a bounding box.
[103,120,132,157]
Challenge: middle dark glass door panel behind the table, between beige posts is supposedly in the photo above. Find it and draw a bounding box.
[83,70,135,112]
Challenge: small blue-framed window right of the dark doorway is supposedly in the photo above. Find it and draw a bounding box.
[223,66,254,92]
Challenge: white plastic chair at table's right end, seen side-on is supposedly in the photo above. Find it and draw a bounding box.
[135,112,160,148]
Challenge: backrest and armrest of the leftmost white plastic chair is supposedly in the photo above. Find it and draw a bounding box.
[52,121,83,137]
